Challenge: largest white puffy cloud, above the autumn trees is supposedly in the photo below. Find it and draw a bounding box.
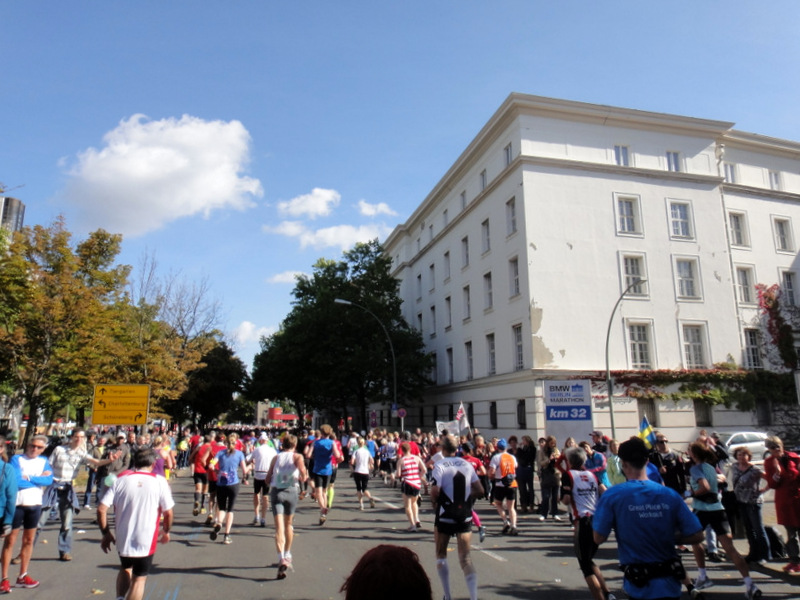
[65,114,264,236]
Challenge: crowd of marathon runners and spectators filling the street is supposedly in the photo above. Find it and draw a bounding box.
[0,425,800,600]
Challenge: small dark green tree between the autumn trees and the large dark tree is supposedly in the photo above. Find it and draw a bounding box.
[175,341,247,425]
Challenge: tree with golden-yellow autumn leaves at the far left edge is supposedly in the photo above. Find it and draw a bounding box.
[0,218,130,446]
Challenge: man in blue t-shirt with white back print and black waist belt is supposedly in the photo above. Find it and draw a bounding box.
[592,438,703,600]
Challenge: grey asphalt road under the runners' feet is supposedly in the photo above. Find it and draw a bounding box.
[10,473,800,600]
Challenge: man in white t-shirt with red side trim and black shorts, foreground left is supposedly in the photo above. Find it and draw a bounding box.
[97,447,175,600]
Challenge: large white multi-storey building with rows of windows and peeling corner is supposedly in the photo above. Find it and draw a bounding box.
[381,94,800,441]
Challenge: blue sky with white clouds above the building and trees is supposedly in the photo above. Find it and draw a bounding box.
[0,0,800,365]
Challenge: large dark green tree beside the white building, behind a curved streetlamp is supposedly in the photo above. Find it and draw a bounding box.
[247,240,432,425]
